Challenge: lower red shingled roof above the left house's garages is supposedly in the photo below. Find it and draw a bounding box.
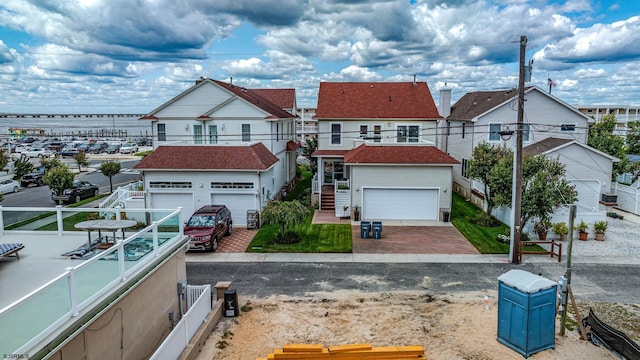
[134,143,278,170]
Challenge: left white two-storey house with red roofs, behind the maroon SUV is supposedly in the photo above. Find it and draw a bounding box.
[136,79,297,225]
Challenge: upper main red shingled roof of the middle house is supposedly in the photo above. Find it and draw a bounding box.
[314,82,442,119]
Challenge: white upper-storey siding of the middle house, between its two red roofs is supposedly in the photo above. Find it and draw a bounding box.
[318,119,437,150]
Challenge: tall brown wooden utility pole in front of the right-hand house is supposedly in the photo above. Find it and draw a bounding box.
[509,36,527,264]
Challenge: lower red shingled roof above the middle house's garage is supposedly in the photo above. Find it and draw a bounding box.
[344,144,459,165]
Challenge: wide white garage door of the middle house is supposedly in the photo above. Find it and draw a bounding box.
[362,189,438,220]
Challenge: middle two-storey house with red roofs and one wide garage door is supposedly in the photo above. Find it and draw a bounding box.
[313,82,458,220]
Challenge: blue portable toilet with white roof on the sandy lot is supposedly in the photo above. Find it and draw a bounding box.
[498,270,557,357]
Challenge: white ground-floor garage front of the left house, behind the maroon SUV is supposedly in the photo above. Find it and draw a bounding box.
[144,170,264,225]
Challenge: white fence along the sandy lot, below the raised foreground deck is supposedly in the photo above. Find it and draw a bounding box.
[149,285,211,360]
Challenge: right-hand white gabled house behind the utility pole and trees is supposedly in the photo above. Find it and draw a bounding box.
[442,87,618,223]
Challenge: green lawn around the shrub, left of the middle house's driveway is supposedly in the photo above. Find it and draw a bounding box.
[246,210,352,253]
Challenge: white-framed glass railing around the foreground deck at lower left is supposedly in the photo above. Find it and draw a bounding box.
[0,207,185,354]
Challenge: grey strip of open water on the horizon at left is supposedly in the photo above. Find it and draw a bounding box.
[0,114,151,137]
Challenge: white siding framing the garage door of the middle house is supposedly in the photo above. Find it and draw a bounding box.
[349,165,452,221]
